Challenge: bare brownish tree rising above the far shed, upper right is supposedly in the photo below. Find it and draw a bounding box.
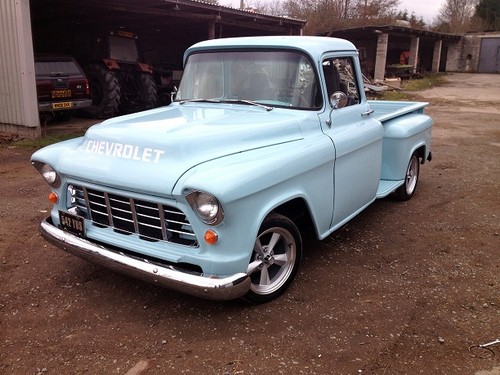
[437,0,478,33]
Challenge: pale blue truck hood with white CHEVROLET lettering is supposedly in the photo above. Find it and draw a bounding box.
[47,103,305,195]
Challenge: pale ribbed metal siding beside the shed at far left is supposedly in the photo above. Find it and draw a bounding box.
[0,0,40,128]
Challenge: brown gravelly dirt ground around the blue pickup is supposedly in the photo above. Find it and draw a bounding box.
[0,74,500,375]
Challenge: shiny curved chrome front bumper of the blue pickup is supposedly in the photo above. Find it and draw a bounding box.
[40,218,250,300]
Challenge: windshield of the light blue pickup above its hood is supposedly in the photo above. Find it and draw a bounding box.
[176,50,321,109]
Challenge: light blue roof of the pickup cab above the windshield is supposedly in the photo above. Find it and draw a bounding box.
[184,36,356,63]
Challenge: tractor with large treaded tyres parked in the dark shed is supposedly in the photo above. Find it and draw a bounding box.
[78,31,158,118]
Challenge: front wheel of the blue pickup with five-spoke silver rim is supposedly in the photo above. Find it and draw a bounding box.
[244,214,302,303]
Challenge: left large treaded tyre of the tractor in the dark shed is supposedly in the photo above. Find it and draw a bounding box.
[84,64,121,119]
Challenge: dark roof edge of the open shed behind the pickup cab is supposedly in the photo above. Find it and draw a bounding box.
[31,0,306,35]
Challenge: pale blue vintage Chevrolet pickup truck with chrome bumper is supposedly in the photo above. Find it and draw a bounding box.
[32,36,432,303]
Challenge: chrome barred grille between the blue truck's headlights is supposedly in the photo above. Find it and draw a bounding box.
[69,185,198,246]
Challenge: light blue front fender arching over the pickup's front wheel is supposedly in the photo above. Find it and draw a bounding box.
[172,134,335,269]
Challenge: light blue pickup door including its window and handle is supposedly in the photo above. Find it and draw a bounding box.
[320,55,383,228]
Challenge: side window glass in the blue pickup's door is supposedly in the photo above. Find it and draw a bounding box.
[323,57,360,106]
